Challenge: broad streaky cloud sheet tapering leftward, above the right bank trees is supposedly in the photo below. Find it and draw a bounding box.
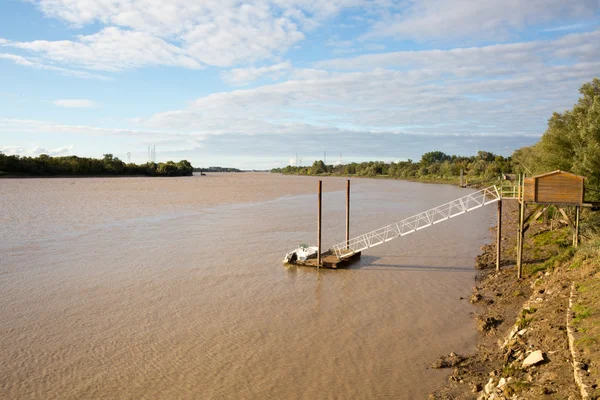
[138,31,600,136]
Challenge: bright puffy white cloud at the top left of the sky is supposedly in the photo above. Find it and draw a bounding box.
[9,0,367,71]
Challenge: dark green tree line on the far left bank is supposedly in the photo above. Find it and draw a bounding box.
[0,153,193,176]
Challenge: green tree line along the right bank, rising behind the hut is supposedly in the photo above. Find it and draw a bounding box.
[271,78,600,199]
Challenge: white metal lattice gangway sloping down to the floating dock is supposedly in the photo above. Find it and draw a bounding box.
[331,186,502,259]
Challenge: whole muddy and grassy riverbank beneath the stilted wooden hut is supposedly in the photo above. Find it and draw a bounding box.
[430,201,600,399]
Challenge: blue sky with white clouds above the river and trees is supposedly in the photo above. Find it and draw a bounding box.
[0,0,600,169]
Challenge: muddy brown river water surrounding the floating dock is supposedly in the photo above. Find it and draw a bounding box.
[0,173,494,399]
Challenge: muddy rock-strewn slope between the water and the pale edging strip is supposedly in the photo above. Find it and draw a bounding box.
[430,201,595,400]
